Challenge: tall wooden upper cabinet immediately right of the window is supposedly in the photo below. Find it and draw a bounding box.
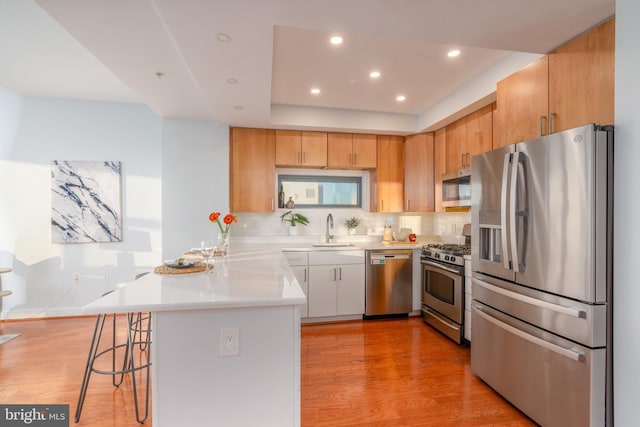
[371,135,404,212]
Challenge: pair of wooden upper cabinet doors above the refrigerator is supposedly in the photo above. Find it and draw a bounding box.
[494,18,615,147]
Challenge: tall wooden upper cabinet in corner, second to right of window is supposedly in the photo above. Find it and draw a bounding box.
[404,133,434,212]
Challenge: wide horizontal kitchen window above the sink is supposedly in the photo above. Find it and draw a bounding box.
[278,175,362,208]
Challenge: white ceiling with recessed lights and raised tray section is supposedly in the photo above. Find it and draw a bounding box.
[0,0,615,133]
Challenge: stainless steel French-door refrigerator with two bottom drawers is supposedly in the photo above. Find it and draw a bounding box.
[471,125,613,427]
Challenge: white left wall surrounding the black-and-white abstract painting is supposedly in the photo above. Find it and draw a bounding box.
[0,91,162,318]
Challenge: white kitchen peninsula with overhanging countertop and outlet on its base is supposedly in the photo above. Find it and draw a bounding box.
[83,249,306,427]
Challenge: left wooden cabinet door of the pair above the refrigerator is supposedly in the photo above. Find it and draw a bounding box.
[494,56,549,147]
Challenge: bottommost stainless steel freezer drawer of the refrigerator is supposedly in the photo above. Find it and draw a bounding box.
[471,301,606,427]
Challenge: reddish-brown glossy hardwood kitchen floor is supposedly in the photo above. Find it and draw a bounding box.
[0,317,534,427]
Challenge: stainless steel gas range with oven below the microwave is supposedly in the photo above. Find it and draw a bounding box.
[420,244,471,344]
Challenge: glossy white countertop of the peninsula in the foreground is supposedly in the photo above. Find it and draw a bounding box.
[82,248,306,314]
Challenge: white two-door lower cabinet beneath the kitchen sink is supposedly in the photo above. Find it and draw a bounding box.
[308,251,364,317]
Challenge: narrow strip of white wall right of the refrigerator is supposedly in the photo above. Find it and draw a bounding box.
[613,0,640,426]
